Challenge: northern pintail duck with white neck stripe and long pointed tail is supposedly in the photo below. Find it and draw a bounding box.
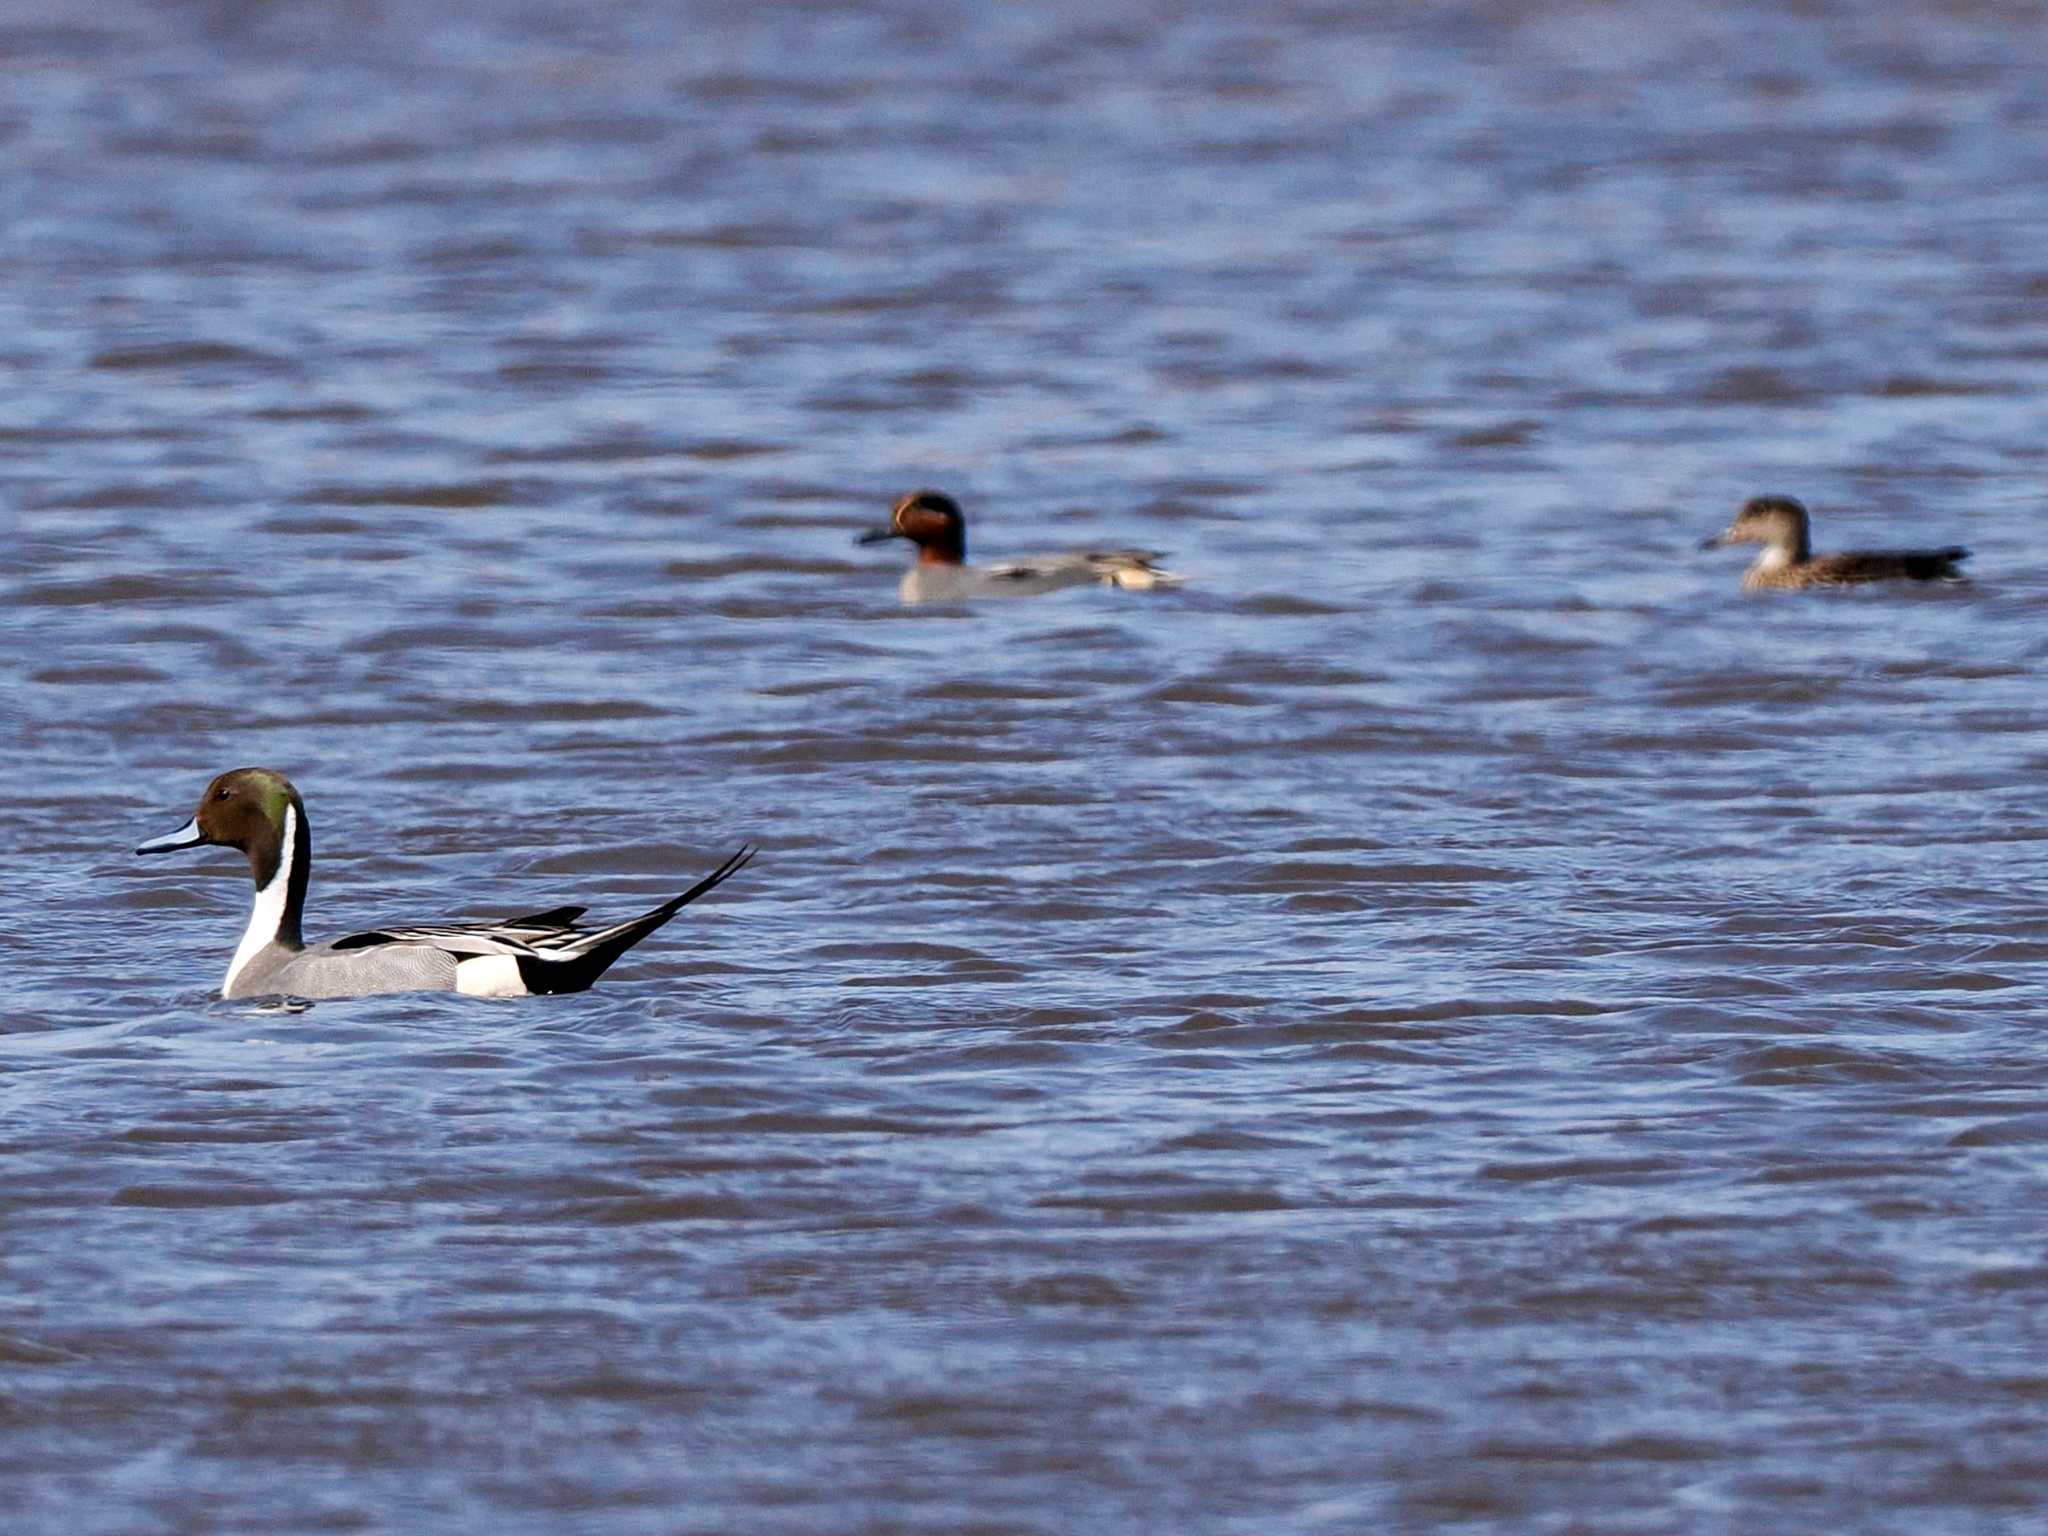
[135,768,754,997]
